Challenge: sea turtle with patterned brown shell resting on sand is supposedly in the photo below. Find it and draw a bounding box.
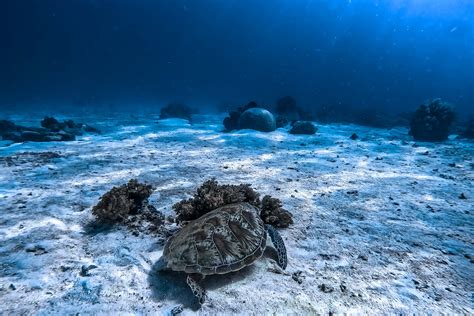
[160,202,287,304]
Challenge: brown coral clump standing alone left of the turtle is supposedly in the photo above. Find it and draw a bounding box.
[92,179,153,223]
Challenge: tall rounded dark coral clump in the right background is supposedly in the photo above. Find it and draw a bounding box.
[410,99,455,142]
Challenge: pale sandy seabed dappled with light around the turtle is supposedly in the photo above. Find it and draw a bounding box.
[0,115,474,315]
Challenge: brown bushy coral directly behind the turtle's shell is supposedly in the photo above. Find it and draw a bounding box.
[173,179,293,227]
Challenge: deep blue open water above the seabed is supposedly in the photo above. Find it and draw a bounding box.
[0,0,474,113]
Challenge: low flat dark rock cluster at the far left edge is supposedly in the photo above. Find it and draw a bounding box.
[0,117,100,143]
